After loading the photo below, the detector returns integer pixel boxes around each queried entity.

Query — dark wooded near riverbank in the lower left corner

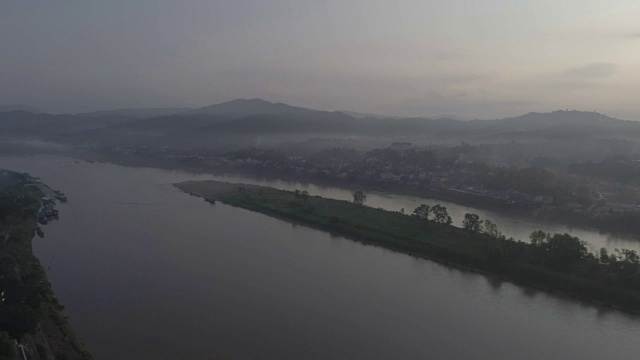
[0,170,91,359]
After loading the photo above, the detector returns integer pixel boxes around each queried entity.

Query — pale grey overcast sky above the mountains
[0,0,640,120]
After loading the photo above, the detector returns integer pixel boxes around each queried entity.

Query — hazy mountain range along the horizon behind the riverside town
[0,99,640,155]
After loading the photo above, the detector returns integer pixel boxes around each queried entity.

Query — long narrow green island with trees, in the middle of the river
[176,181,640,313]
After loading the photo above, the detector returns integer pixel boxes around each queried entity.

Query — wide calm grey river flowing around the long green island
[0,156,640,360]
